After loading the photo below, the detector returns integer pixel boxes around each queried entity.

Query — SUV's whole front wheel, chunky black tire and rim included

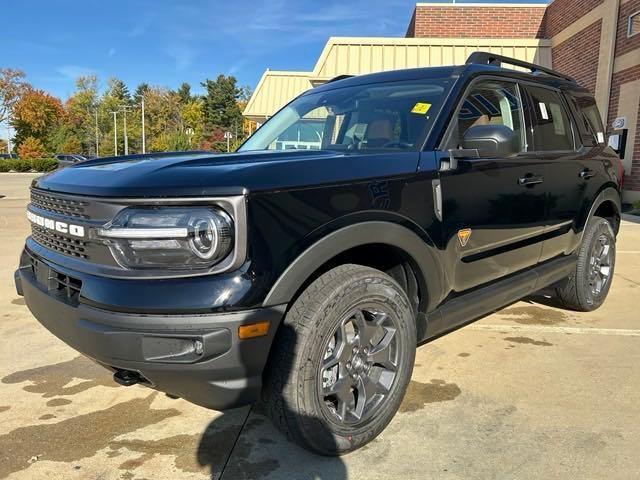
[263,265,416,455]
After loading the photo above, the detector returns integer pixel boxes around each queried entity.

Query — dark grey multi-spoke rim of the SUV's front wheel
[318,305,403,426]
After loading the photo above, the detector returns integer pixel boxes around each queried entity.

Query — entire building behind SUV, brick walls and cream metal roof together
[244,0,640,202]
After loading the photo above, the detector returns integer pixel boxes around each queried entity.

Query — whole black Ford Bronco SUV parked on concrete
[15,53,621,454]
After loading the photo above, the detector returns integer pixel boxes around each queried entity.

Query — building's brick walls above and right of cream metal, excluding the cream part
[407,0,640,201]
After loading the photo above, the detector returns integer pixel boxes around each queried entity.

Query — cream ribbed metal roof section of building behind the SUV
[244,37,551,122]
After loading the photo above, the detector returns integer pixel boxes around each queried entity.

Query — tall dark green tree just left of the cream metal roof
[202,75,242,130]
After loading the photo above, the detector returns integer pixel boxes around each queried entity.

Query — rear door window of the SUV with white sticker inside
[525,86,574,151]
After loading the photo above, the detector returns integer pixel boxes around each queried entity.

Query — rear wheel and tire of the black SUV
[556,217,616,312]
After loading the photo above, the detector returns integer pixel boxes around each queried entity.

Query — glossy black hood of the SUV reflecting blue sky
[34,150,418,197]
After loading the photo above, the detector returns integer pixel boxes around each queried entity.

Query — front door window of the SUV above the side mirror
[447,81,525,151]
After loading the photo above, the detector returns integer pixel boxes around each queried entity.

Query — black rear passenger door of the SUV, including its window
[523,85,602,261]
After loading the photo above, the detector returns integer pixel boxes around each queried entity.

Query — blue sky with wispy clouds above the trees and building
[0,0,544,99]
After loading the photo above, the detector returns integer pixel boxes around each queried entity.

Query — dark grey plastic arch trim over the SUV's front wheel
[263,221,442,311]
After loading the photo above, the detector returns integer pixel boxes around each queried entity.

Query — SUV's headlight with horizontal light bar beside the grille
[98,207,234,270]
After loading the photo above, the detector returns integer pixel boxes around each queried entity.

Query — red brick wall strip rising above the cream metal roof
[406,3,545,38]
